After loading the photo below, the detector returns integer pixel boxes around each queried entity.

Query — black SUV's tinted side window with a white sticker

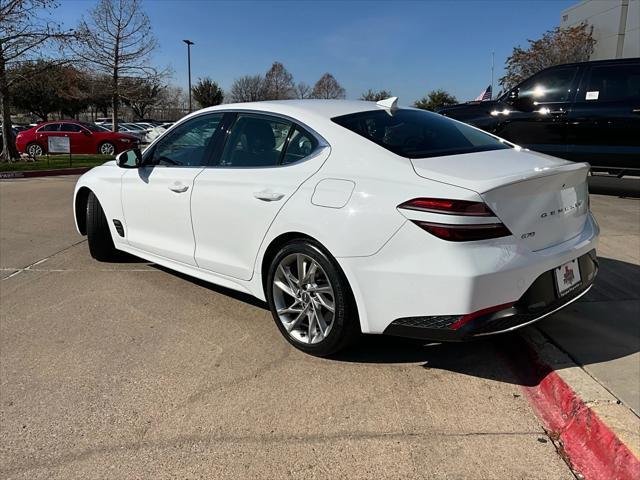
[580,64,640,102]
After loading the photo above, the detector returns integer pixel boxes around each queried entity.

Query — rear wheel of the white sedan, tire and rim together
[266,240,360,357]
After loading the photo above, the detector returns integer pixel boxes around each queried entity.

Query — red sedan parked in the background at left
[16,120,140,157]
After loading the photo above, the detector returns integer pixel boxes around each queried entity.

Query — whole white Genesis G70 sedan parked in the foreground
[74,99,599,355]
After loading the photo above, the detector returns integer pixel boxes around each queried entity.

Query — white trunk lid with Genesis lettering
[412,150,589,251]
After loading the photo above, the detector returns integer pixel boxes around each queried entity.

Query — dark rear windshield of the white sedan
[332,110,511,158]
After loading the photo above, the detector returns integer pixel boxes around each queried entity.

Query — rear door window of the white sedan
[220,114,291,167]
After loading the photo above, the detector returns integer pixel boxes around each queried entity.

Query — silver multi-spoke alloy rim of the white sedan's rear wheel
[272,253,335,344]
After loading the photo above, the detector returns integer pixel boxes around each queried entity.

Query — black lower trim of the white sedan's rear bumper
[384,250,598,341]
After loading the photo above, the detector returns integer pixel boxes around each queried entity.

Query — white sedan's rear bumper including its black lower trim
[338,215,599,340]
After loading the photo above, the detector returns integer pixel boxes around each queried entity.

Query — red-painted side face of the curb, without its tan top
[512,339,640,480]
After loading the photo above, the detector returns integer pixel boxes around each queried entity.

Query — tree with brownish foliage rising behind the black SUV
[499,23,596,90]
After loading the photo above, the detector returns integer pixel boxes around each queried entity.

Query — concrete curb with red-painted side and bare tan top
[513,328,640,480]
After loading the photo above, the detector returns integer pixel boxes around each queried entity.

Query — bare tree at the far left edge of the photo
[0,0,73,161]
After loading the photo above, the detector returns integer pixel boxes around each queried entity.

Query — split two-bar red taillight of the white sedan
[398,198,511,242]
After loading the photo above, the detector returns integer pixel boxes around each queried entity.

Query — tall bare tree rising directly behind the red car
[75,0,158,132]
